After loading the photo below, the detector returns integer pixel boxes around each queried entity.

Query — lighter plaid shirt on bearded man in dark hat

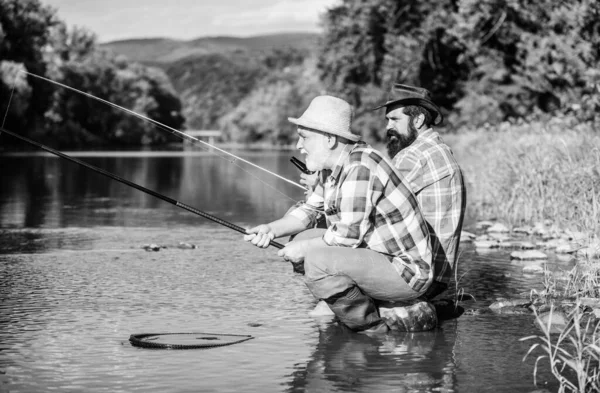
[393,129,467,284]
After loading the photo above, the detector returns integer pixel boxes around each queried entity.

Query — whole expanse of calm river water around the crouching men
[0,151,569,392]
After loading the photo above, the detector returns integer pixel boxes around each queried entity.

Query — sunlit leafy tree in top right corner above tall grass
[452,0,600,123]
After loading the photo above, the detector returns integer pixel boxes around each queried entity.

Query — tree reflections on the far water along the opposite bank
[0,152,303,228]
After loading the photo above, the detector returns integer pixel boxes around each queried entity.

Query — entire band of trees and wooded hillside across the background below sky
[0,0,600,146]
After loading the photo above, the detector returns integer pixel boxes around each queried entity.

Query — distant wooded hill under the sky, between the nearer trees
[101,33,318,129]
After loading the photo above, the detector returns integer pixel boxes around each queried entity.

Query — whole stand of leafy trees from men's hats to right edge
[318,0,600,138]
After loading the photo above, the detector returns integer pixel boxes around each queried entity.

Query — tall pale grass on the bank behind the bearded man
[446,118,600,234]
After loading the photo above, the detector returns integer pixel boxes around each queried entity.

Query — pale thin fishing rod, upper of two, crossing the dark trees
[19,70,307,191]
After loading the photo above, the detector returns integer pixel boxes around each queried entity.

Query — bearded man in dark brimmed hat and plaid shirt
[375,84,466,299]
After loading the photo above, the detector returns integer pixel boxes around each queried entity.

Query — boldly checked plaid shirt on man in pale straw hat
[289,143,433,292]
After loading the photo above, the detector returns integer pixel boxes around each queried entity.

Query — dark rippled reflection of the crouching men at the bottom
[288,321,457,392]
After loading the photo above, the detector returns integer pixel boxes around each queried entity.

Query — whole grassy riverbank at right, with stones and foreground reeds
[445,117,600,391]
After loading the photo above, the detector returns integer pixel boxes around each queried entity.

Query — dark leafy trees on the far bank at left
[0,0,184,147]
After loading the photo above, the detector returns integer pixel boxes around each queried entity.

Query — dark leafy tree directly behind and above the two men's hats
[319,0,468,139]
